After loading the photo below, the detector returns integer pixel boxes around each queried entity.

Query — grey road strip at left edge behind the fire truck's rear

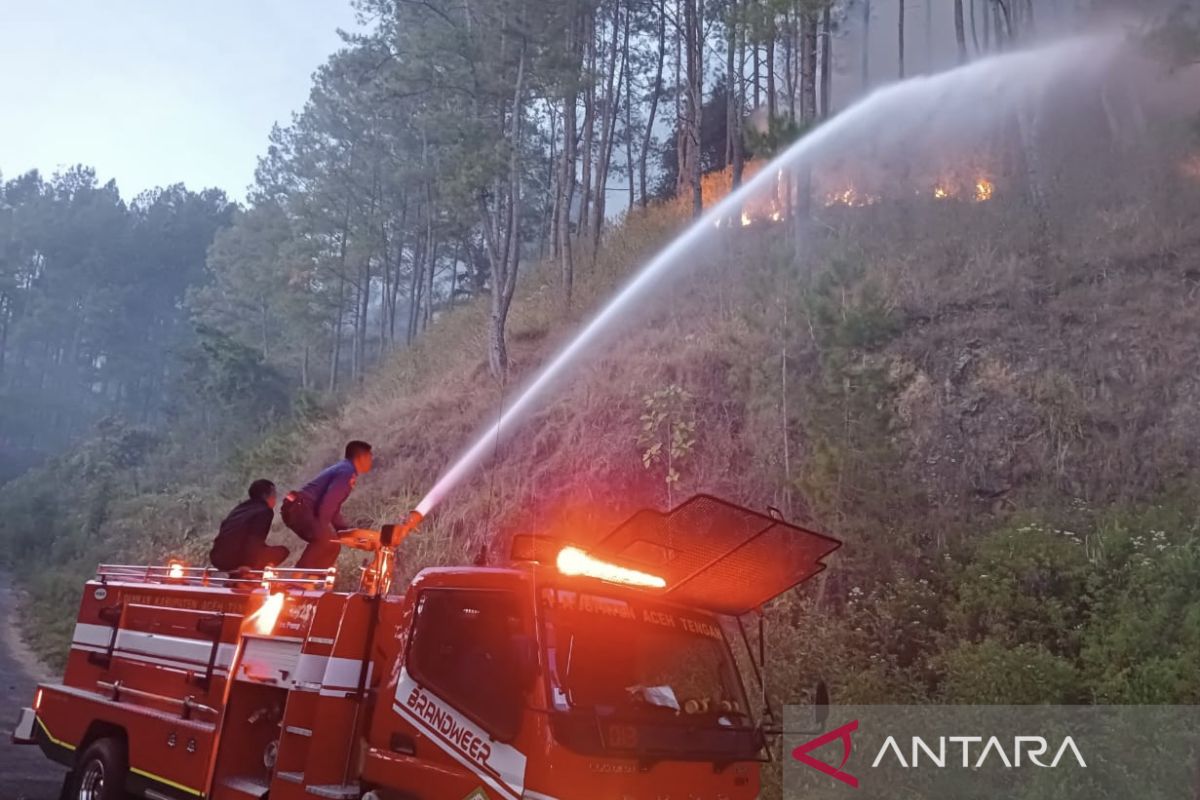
[0,576,62,800]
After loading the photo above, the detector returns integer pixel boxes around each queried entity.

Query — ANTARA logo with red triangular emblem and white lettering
[792,720,1087,788]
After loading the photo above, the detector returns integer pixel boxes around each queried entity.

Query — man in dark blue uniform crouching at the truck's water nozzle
[282,441,372,570]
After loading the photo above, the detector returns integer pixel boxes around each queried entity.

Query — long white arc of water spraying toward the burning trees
[404,36,1120,533]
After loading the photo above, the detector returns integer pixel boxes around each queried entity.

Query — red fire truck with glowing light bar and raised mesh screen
[14,495,839,800]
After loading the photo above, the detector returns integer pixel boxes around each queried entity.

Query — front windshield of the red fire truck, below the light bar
[541,588,752,728]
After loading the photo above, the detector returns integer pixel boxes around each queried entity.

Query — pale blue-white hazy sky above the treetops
[0,0,354,199]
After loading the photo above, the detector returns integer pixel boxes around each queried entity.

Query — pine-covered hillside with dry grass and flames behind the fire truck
[0,0,1200,772]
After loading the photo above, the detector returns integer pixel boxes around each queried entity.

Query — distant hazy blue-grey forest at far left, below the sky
[0,175,233,481]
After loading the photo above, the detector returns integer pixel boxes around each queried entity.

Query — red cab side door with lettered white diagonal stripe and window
[392,588,528,800]
